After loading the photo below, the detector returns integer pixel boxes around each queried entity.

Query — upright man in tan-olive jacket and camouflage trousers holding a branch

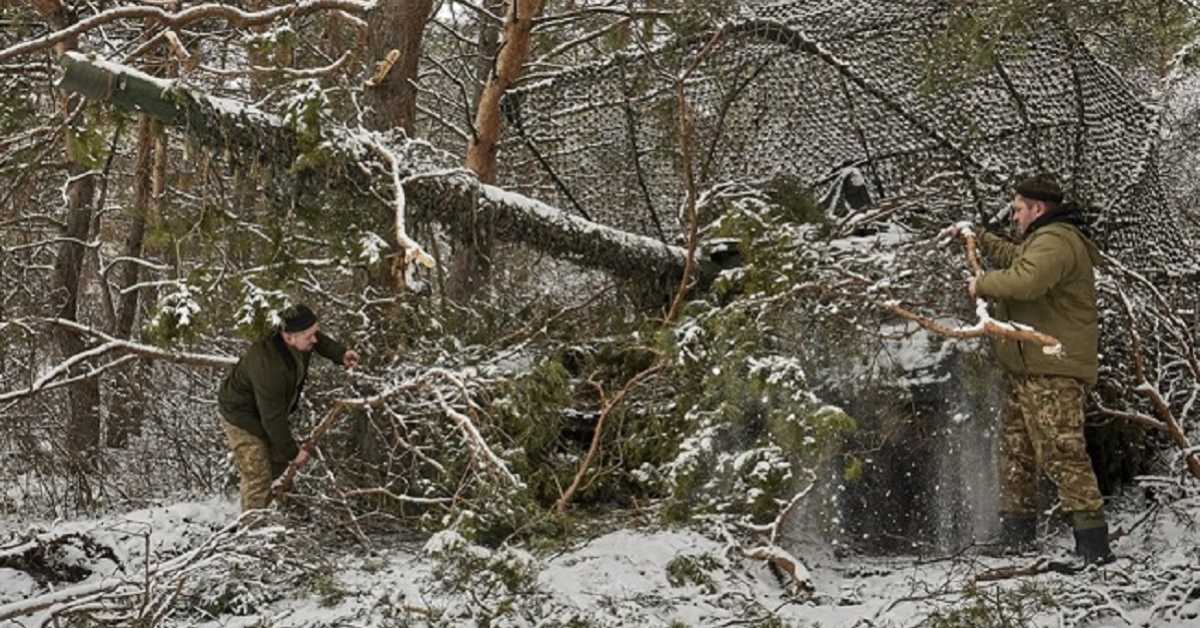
[955,175,1114,563]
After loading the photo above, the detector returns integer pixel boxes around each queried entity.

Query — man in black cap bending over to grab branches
[217,305,359,513]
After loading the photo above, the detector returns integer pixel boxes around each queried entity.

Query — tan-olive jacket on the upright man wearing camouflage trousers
[976,216,1100,384]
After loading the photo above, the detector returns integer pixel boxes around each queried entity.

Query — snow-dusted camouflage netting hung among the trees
[504,0,1198,274]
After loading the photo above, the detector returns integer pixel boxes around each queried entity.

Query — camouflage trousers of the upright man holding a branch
[1000,376,1104,513]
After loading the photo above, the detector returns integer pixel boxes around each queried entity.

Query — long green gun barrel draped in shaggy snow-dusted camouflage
[60,53,685,286]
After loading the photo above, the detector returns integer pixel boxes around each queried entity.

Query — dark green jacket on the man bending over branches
[217,331,346,463]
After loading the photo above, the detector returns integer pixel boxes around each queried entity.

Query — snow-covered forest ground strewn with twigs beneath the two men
[0,497,1200,628]
